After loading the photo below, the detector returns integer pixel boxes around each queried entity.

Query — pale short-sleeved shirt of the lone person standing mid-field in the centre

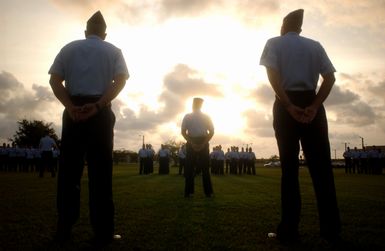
[182,111,214,137]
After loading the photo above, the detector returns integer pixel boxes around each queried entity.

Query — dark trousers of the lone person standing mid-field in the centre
[184,139,213,196]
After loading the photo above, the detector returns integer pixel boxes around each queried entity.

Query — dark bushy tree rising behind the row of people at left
[10,119,59,147]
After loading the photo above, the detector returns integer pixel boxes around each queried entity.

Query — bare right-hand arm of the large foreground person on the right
[305,72,336,123]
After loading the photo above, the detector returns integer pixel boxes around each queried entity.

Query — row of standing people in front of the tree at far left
[0,136,60,177]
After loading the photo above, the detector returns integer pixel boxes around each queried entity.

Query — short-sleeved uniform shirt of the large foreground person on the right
[260,32,336,91]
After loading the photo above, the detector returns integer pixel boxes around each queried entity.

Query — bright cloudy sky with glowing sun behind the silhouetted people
[0,0,385,158]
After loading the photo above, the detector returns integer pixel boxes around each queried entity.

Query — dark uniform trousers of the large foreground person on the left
[57,98,115,240]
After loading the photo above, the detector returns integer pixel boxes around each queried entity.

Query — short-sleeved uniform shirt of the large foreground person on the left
[49,35,129,96]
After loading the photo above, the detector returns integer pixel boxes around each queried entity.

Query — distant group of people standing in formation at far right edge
[344,146,385,174]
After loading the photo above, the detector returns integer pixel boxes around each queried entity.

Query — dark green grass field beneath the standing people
[0,165,385,251]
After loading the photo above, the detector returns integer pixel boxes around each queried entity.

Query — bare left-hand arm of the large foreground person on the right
[266,67,304,122]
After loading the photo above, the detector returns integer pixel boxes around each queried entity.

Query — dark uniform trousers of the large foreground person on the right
[273,91,341,239]
